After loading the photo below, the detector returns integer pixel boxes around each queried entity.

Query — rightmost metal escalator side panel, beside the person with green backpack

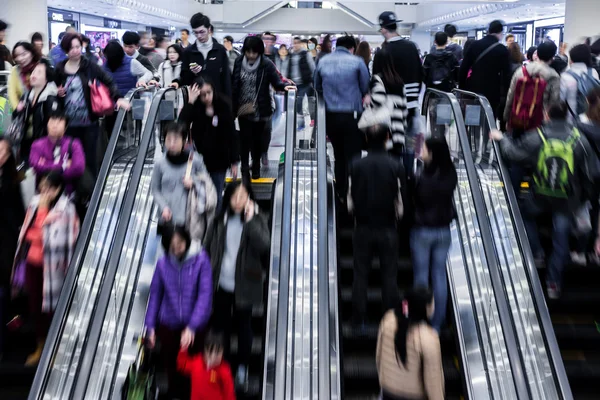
[456,90,573,399]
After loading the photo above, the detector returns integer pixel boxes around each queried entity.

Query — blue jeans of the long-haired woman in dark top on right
[410,227,452,332]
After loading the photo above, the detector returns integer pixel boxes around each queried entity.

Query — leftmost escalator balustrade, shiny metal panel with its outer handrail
[24,89,157,399]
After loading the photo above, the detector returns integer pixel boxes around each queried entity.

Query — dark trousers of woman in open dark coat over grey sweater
[213,287,253,366]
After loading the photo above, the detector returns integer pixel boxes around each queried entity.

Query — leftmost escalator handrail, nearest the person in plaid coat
[28,88,153,400]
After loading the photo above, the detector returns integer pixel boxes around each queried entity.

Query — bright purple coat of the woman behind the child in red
[146,251,213,331]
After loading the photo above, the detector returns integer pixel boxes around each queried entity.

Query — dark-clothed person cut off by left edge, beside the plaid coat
[0,137,25,357]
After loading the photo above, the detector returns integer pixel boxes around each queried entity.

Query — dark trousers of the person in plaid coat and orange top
[25,263,52,340]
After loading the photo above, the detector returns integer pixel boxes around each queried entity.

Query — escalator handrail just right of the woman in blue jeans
[423,89,531,400]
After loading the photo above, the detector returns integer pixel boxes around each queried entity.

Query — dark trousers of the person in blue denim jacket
[326,112,363,200]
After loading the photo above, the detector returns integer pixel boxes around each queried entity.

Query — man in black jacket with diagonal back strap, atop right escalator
[459,21,512,116]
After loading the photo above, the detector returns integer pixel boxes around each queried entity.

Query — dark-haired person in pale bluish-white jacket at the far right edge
[560,44,599,120]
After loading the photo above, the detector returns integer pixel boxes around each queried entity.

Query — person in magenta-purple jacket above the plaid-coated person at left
[29,111,85,196]
